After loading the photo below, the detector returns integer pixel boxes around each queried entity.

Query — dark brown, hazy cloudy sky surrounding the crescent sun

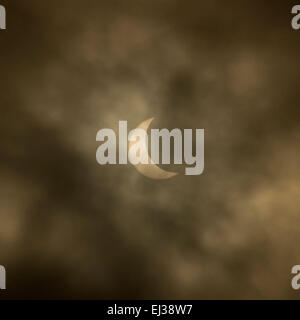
[0,0,300,299]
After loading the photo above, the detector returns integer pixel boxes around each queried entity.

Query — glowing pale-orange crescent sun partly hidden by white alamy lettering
[129,118,177,180]
